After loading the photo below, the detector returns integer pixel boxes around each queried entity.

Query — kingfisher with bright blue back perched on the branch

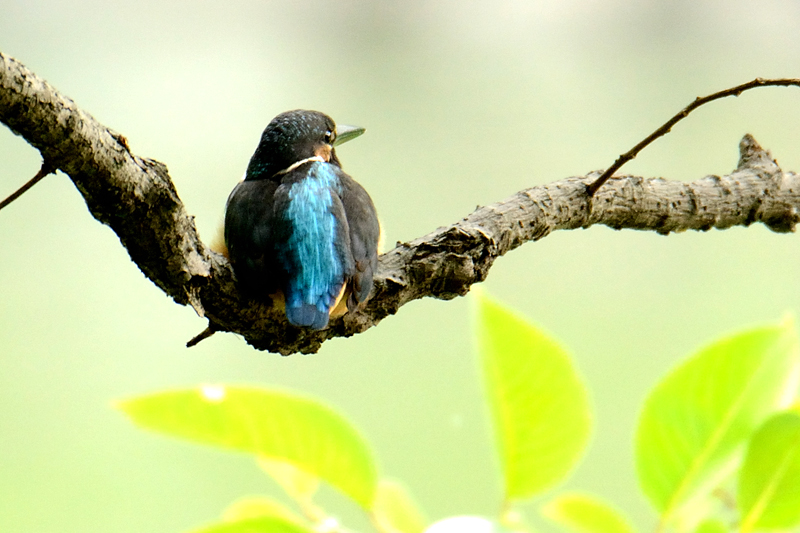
[224,109,380,330]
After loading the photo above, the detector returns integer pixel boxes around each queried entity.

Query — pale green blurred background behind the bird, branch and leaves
[0,0,800,533]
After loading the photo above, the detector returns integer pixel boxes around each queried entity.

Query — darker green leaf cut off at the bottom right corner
[738,411,800,532]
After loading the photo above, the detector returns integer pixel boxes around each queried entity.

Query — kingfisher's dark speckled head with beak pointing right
[245,109,364,180]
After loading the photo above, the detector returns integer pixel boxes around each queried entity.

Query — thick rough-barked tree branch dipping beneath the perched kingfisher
[0,53,800,354]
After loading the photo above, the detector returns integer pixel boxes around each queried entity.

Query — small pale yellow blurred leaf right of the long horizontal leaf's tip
[372,479,428,533]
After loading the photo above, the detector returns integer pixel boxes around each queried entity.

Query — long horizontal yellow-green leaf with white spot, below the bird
[119,386,377,508]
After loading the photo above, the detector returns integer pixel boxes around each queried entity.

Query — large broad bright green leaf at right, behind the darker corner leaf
[636,323,800,522]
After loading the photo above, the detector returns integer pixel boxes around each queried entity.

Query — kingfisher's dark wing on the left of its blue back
[225,180,290,301]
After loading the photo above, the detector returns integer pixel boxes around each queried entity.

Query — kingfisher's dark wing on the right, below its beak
[340,168,381,310]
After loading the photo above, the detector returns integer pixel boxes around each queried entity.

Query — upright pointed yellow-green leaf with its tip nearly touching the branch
[478,295,591,500]
